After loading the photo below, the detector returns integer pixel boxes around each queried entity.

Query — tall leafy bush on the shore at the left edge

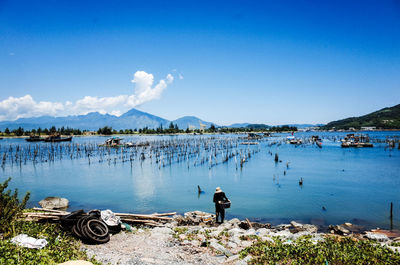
[0,178,30,237]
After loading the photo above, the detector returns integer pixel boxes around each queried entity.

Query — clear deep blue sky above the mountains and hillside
[0,0,400,125]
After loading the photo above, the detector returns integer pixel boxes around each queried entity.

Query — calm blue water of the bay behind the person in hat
[0,132,400,228]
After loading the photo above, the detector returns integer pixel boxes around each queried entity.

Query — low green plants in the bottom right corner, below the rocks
[240,236,400,265]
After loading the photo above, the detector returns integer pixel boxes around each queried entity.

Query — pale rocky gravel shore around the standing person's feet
[82,211,400,265]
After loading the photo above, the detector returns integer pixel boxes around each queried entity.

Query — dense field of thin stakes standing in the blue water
[0,137,260,169]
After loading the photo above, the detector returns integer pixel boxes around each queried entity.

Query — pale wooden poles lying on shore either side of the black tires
[21,208,176,226]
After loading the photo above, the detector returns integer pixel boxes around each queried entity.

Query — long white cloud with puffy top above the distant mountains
[0,71,174,120]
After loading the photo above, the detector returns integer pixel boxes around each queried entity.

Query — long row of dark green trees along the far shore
[0,122,297,136]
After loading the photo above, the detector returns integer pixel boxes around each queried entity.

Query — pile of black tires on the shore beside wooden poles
[61,210,121,244]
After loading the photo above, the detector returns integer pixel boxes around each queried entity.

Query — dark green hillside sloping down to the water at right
[322,104,400,129]
